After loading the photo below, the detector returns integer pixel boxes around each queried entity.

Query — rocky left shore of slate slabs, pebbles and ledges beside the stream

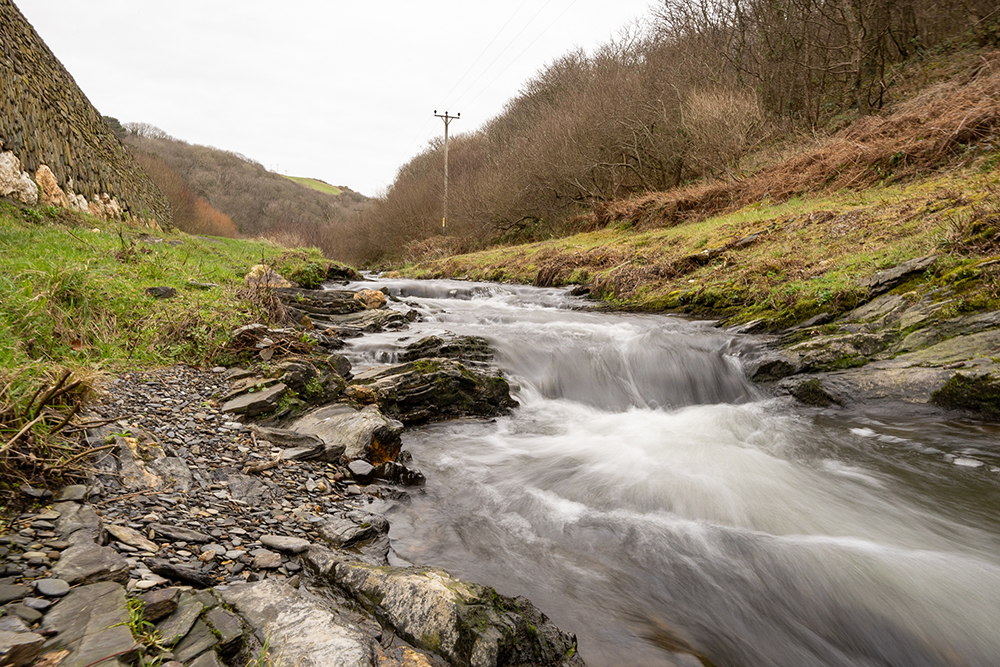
[0,290,583,667]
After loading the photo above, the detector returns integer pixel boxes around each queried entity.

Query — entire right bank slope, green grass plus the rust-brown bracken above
[406,49,1000,328]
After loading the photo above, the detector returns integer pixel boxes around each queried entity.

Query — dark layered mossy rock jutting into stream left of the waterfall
[353,358,517,426]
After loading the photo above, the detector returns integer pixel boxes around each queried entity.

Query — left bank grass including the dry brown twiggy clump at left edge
[0,202,344,503]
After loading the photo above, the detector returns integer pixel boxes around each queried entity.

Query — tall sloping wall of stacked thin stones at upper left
[0,0,170,226]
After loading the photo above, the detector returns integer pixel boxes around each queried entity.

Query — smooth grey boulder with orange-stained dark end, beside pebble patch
[291,404,403,465]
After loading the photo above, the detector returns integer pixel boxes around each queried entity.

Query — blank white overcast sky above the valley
[14,0,655,195]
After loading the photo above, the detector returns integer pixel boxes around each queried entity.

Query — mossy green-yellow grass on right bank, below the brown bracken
[408,164,1000,327]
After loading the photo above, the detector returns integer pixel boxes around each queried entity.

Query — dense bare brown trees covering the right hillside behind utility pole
[336,0,1000,263]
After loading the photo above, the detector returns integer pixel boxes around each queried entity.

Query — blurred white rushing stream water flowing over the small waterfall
[334,280,1000,667]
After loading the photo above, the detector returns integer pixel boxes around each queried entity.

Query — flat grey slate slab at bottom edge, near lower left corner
[43,582,135,667]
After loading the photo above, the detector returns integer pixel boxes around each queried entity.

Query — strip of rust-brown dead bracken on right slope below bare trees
[594,51,1000,227]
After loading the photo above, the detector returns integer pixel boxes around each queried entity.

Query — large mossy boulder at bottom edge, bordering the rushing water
[334,562,583,667]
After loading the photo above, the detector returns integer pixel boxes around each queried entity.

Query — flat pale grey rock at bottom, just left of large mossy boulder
[220,579,374,667]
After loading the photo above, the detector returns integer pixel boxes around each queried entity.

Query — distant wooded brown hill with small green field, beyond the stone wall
[123,129,369,256]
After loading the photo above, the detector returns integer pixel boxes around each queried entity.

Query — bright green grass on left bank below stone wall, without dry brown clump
[0,204,323,374]
